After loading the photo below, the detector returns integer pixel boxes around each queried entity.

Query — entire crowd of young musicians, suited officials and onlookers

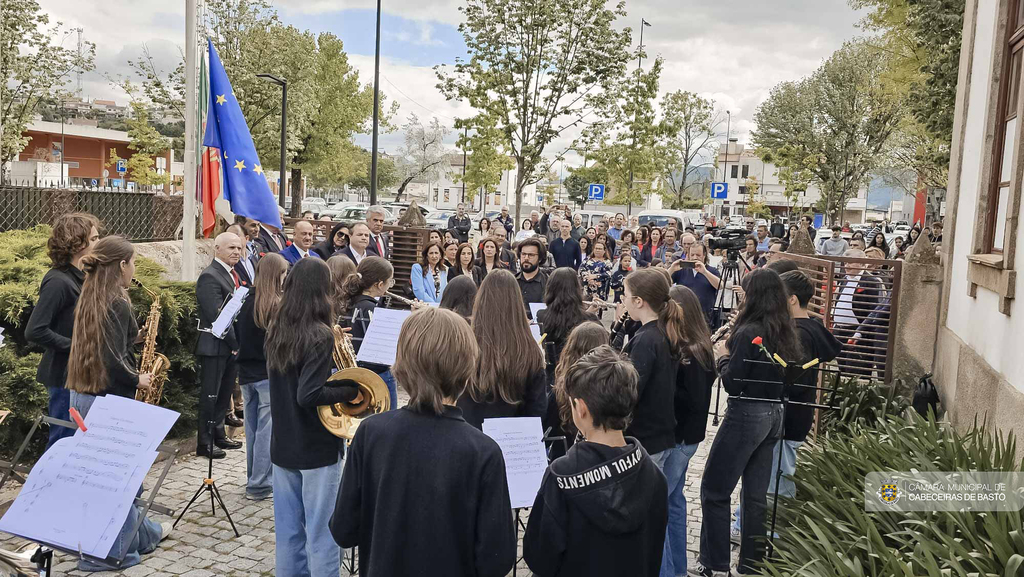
[27,206,941,577]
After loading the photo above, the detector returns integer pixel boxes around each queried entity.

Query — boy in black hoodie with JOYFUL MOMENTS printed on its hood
[523,345,669,577]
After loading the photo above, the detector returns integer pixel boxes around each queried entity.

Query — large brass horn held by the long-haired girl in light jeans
[316,325,391,441]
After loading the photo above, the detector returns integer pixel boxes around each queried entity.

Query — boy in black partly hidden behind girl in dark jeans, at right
[732,271,843,542]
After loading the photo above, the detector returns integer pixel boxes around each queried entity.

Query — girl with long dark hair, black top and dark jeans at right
[698,269,803,573]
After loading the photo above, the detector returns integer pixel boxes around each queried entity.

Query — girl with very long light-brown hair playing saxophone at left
[68,237,171,572]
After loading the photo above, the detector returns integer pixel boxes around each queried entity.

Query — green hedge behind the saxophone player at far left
[0,225,199,457]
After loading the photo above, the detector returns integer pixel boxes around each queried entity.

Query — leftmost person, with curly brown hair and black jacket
[25,212,99,449]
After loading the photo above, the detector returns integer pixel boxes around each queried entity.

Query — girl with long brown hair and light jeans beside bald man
[236,252,288,501]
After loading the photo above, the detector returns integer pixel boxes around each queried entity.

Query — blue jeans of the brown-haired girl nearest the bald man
[242,379,273,498]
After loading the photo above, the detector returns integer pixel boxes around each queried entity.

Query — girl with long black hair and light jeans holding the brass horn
[266,258,361,575]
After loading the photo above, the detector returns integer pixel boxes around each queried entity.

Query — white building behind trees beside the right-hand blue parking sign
[714,138,867,222]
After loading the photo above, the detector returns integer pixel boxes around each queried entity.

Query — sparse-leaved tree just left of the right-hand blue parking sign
[657,90,722,209]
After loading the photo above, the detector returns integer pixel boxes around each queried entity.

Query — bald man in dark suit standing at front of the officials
[196,233,243,459]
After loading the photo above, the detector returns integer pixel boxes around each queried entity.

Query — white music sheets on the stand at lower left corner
[0,395,178,559]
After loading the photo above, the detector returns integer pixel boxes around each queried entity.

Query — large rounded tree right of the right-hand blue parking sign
[751,42,904,221]
